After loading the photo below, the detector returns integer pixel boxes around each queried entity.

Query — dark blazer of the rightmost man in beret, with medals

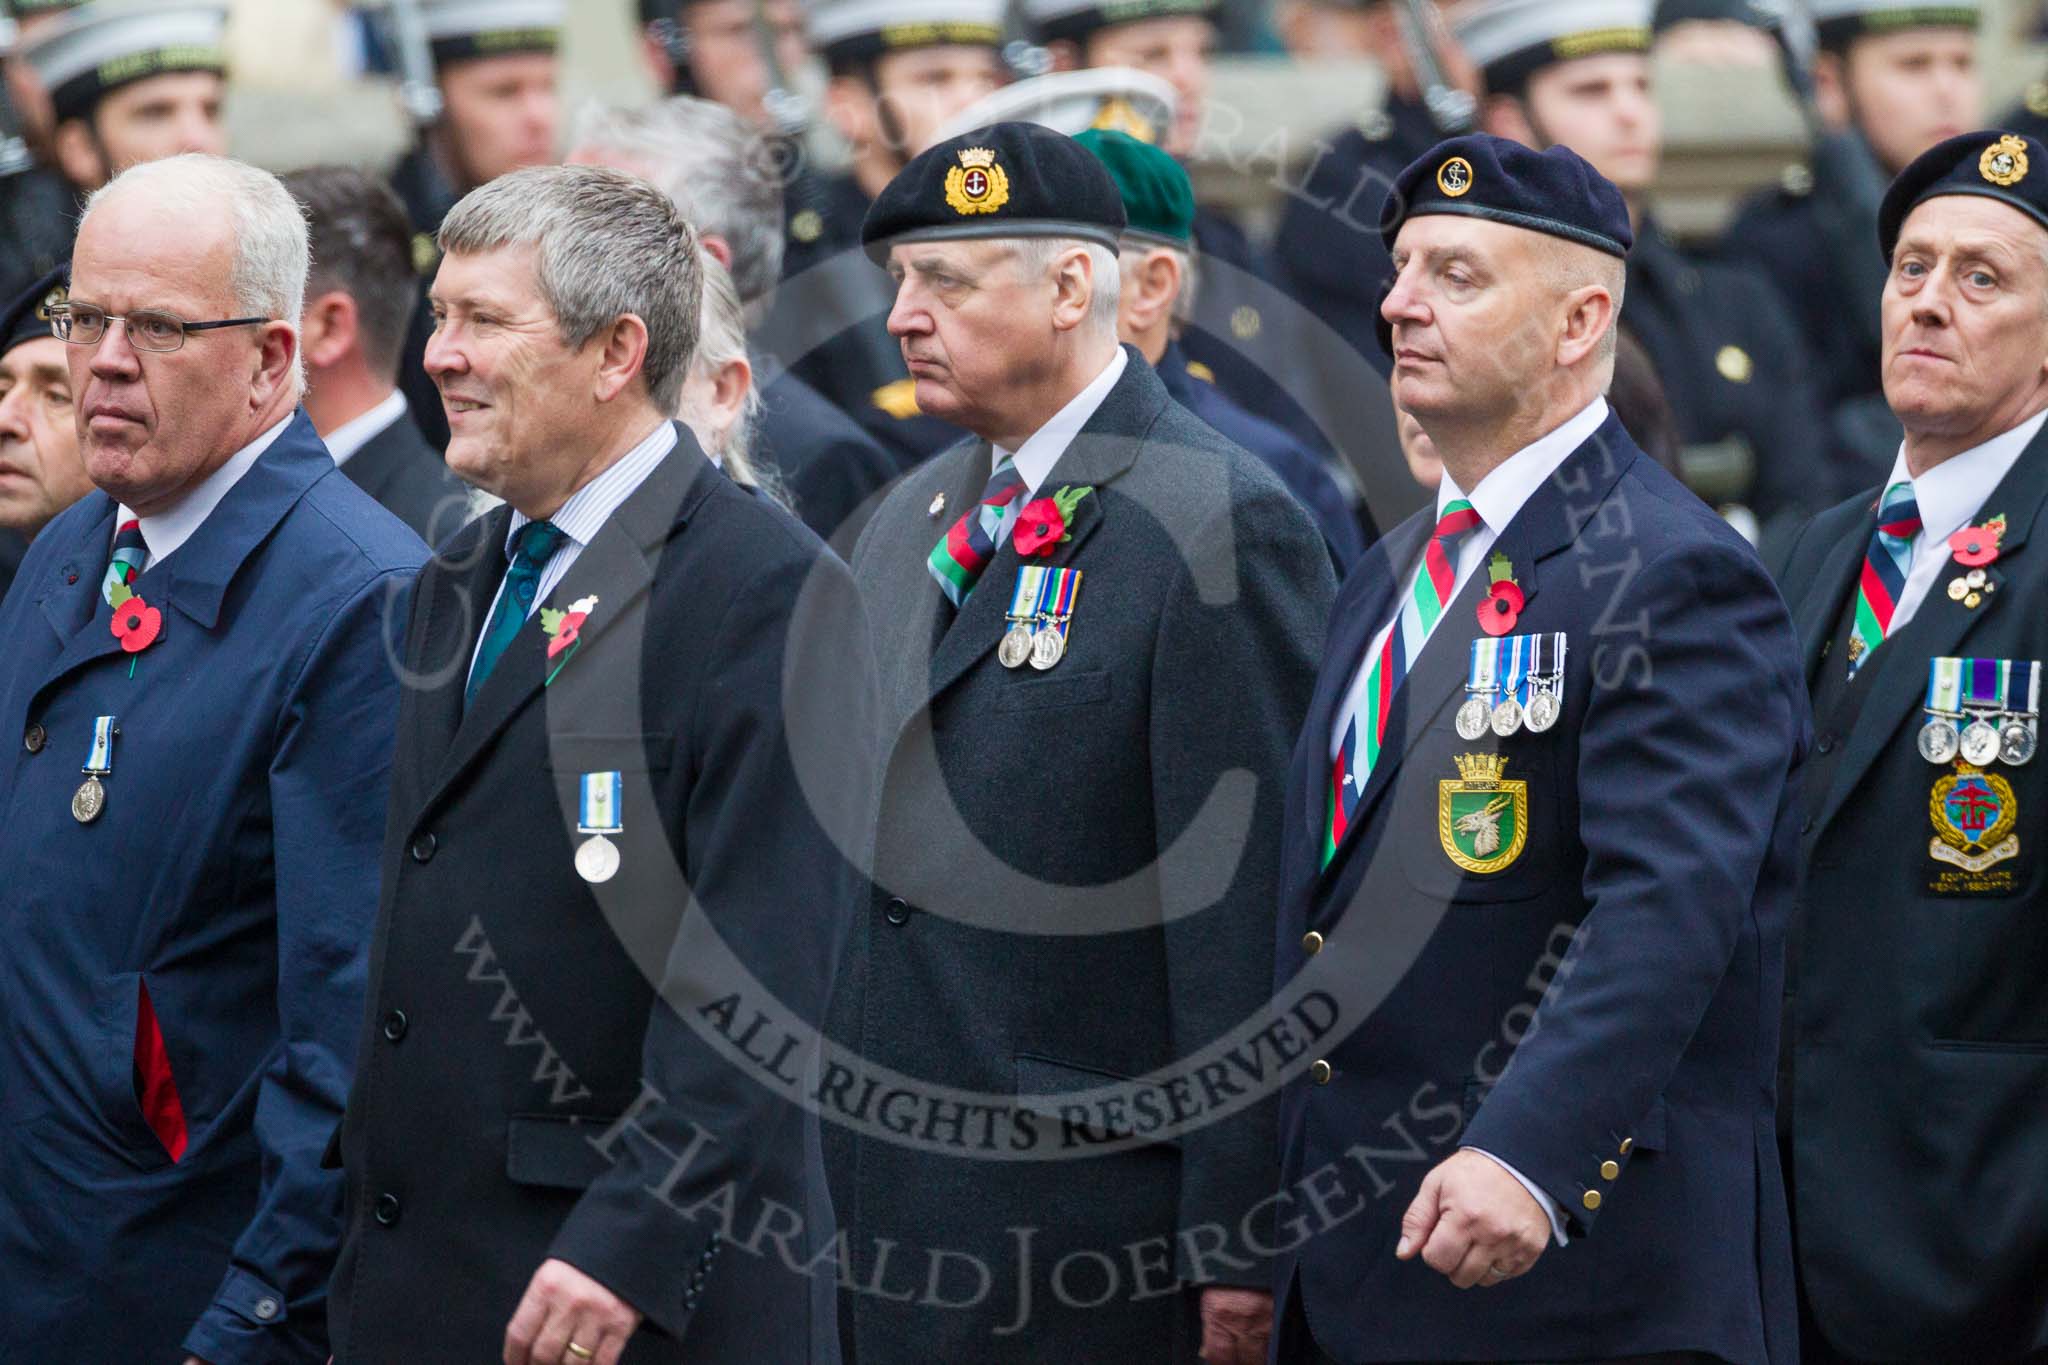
[1782,434,2048,1361]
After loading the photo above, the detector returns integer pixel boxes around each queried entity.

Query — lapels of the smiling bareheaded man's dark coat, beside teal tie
[411,432,723,822]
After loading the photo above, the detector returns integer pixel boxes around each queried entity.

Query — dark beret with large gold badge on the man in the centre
[860,123,1126,264]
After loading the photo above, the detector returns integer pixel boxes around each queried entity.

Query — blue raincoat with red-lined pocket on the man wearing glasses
[0,411,426,1365]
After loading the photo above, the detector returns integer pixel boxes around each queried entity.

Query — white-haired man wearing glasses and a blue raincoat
[0,156,426,1365]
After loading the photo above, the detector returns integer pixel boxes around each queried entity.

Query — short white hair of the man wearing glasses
[84,151,311,393]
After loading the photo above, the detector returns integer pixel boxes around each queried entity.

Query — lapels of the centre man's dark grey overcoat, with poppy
[928,348,1171,700]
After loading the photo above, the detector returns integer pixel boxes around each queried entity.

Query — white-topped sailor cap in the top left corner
[20,0,227,119]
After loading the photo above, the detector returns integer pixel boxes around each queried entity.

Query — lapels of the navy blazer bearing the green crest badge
[1325,413,1638,888]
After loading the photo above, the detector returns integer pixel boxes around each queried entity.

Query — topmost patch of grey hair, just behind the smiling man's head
[569,94,782,311]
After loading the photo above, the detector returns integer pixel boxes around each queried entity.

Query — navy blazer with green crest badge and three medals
[1276,417,1808,1363]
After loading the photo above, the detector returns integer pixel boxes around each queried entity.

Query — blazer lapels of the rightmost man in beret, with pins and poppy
[1815,430,2048,829]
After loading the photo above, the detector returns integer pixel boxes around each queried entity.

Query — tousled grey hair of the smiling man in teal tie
[438,166,702,413]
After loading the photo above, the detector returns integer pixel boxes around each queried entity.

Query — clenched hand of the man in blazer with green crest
[1395,1152,1550,1289]
